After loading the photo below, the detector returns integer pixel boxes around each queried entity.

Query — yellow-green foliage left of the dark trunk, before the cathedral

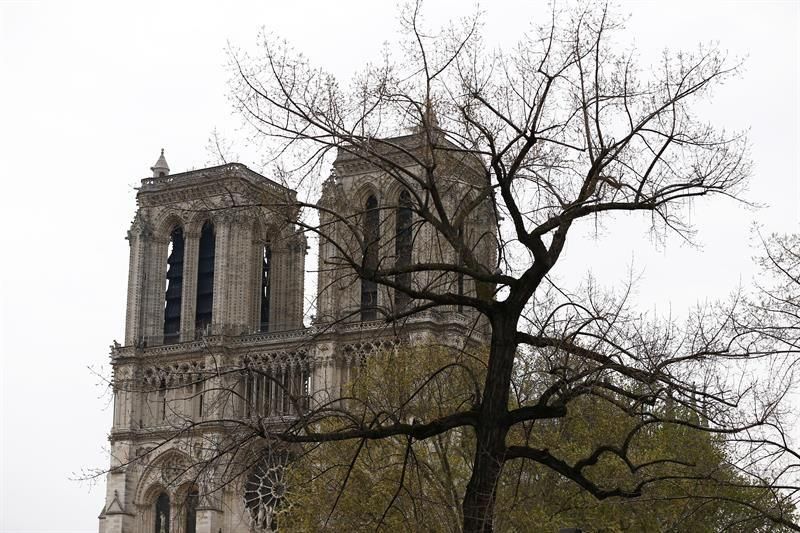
[279,346,483,531]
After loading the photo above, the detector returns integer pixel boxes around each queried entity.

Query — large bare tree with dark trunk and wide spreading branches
[95,4,800,532]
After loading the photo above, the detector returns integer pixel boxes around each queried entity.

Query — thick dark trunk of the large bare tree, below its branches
[462,324,516,533]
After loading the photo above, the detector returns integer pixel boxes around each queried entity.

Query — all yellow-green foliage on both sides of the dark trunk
[279,347,793,532]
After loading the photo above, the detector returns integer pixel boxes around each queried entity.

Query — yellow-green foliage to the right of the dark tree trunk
[497,396,793,532]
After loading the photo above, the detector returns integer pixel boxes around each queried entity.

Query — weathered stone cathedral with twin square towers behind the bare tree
[99,134,496,533]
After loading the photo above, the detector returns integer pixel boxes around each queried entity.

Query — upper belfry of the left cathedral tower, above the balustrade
[125,150,305,346]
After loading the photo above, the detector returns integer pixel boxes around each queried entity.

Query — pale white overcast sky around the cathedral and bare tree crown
[0,0,800,532]
